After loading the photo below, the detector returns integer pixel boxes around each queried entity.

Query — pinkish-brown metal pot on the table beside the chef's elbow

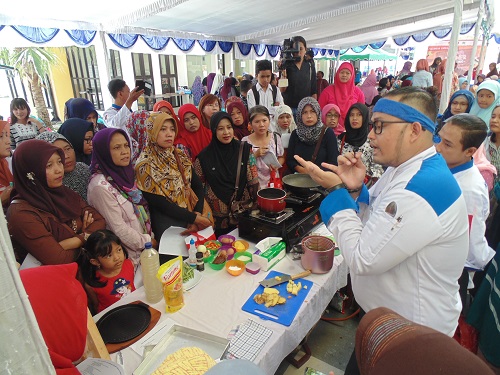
[300,236,335,273]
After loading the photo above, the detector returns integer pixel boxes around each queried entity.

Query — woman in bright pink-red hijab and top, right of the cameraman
[318,62,366,136]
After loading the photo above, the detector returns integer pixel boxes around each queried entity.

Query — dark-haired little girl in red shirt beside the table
[78,229,135,312]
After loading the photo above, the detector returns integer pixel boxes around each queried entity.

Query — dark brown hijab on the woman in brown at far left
[12,139,81,222]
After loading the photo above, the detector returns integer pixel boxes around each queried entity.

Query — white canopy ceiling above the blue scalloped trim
[0,0,492,49]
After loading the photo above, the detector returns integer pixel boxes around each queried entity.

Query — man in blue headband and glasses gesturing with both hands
[296,87,468,352]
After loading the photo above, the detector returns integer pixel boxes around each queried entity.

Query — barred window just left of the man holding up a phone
[66,46,104,110]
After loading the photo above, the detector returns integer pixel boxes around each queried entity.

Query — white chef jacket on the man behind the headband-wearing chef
[451,160,495,270]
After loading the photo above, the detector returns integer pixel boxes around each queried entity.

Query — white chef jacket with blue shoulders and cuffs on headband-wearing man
[320,147,468,336]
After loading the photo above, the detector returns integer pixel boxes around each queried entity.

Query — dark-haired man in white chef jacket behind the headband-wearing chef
[436,113,495,302]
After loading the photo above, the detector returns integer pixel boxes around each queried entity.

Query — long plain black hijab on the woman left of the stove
[198,112,251,204]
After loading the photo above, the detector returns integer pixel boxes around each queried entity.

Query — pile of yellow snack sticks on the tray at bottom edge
[153,347,215,375]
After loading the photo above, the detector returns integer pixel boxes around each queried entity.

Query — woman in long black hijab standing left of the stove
[194,112,259,236]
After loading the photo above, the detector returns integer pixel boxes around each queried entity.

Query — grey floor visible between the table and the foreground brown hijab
[275,311,359,375]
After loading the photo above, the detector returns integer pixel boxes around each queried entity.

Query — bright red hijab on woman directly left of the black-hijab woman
[175,103,212,161]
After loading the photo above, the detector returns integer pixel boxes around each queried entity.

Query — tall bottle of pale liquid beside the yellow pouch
[141,242,163,303]
